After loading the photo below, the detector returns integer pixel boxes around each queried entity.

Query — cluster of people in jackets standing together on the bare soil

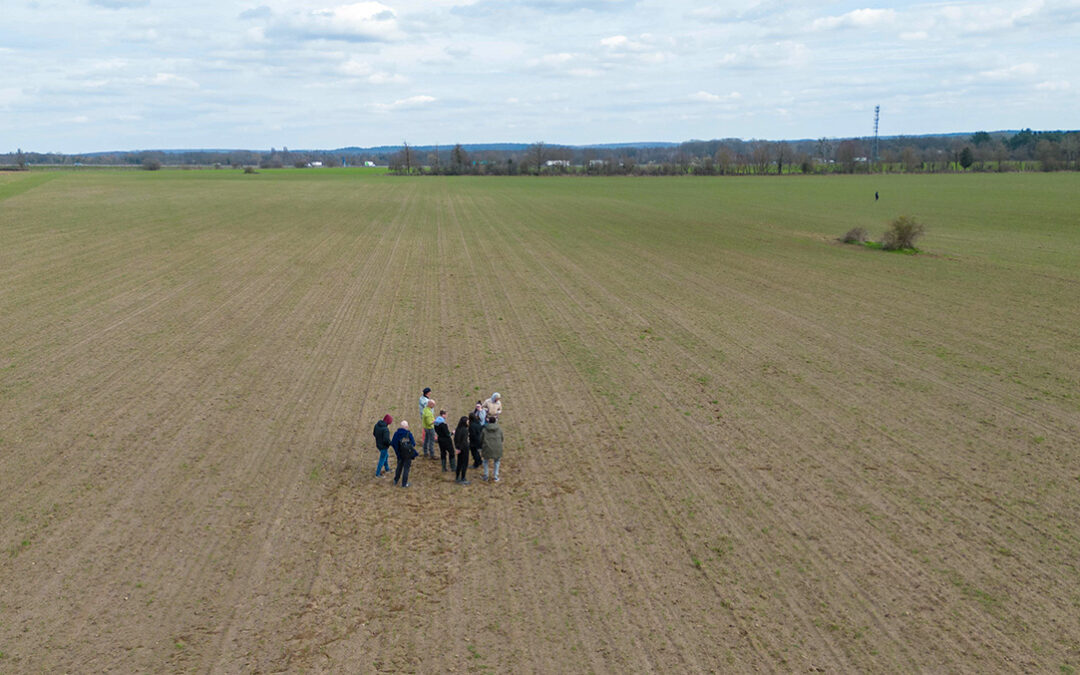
[372,387,502,487]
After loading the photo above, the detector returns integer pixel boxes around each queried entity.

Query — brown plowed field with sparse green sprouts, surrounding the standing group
[0,171,1080,673]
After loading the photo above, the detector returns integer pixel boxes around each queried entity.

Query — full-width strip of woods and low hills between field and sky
[0,129,1080,176]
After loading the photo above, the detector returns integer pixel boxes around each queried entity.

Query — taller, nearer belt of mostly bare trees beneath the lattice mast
[389,129,1080,176]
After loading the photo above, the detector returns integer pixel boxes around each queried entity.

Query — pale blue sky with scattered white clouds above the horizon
[0,0,1080,152]
